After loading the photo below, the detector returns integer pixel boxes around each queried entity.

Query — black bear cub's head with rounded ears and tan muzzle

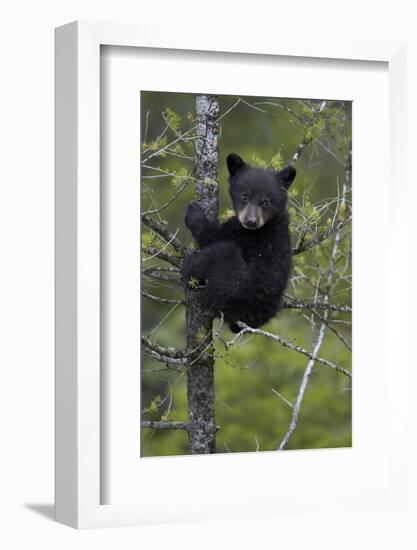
[227,153,296,230]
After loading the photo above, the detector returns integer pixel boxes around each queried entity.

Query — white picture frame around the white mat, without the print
[56,22,406,528]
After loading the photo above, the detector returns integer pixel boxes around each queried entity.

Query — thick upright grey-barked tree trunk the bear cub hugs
[186,95,219,454]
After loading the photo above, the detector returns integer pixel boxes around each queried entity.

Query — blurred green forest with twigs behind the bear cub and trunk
[141,91,352,456]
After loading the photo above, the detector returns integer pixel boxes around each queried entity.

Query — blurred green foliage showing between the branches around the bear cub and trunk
[141,92,352,456]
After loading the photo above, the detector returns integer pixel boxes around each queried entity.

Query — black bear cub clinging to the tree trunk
[182,153,296,332]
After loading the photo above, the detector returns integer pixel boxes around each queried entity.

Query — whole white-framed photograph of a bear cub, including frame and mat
[56,22,407,528]
